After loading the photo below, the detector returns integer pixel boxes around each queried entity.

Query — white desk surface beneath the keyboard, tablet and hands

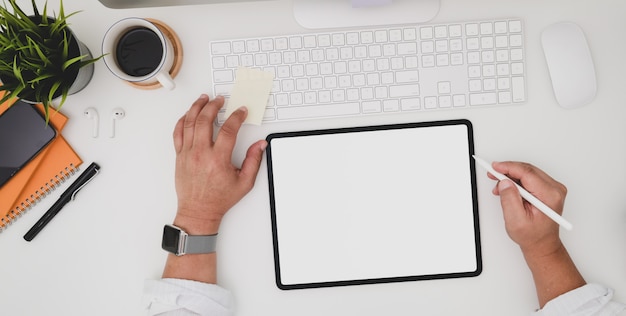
[0,0,626,316]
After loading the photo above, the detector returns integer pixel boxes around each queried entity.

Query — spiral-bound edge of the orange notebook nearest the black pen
[0,164,80,233]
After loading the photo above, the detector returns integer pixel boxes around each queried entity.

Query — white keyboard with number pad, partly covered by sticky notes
[210,19,526,123]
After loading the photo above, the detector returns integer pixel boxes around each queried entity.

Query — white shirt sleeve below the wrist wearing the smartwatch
[143,279,233,316]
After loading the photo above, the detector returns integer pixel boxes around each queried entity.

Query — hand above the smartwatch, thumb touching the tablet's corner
[174,95,267,235]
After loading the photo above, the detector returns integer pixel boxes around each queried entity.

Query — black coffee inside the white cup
[115,27,163,77]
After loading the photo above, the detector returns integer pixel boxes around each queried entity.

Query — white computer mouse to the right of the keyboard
[541,22,597,109]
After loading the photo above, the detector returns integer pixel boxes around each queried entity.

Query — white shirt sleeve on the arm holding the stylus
[532,284,626,316]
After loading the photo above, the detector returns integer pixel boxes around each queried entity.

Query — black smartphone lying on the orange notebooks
[0,101,57,188]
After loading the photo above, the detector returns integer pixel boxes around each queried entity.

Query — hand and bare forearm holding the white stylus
[489,162,586,308]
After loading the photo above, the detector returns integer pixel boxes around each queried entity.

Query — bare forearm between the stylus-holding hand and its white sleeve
[522,243,586,308]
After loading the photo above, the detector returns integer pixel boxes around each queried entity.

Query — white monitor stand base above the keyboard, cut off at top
[293,0,440,29]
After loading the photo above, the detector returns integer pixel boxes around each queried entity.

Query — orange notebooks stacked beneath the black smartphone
[0,100,82,231]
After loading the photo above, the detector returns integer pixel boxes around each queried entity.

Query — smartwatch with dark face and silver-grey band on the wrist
[161,225,217,256]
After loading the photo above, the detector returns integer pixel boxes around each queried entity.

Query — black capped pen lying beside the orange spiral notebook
[24,162,100,241]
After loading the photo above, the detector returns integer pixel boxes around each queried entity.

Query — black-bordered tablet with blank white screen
[266,120,482,290]
